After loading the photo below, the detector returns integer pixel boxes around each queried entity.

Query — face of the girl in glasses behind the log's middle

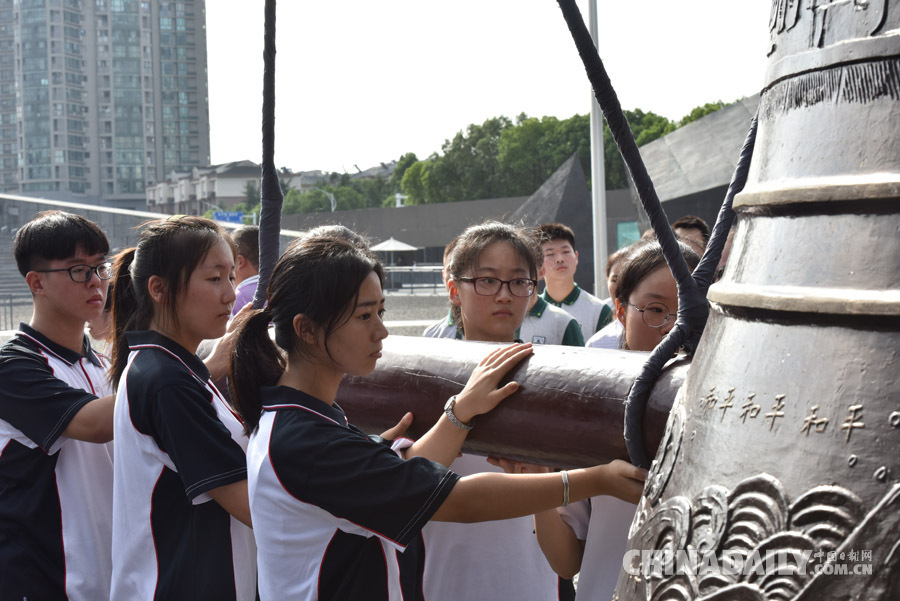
[450,242,532,342]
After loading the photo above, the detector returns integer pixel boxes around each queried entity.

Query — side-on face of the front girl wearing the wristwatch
[317,271,388,376]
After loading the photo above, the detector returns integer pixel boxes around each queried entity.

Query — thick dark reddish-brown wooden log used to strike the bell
[337,336,690,467]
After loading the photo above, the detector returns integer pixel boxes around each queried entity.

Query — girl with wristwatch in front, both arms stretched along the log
[231,232,644,601]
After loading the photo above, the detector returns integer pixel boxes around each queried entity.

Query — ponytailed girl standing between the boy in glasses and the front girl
[112,217,256,601]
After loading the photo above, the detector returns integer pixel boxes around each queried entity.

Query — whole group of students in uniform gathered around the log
[0,211,712,601]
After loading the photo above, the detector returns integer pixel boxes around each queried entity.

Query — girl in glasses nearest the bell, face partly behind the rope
[534,240,700,601]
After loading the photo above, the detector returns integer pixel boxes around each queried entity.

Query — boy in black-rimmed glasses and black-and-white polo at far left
[0,211,115,601]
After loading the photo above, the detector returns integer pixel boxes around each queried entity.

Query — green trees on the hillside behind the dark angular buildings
[282,101,726,214]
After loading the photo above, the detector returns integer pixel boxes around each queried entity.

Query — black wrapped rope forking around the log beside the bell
[558,0,756,468]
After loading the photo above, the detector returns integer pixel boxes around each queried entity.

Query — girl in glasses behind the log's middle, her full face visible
[414,222,571,601]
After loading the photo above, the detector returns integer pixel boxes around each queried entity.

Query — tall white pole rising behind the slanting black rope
[588,0,609,298]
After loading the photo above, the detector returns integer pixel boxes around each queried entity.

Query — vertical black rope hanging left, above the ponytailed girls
[253,0,284,309]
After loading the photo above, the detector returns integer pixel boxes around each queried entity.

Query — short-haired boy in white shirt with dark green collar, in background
[536,223,613,340]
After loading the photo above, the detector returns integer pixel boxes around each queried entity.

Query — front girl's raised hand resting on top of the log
[454,342,534,423]
